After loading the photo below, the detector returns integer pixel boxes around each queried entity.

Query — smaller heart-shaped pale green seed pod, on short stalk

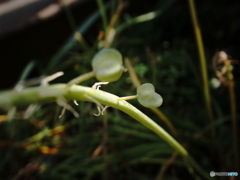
[137,83,163,108]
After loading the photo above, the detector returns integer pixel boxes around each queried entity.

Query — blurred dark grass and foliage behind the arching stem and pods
[0,0,240,180]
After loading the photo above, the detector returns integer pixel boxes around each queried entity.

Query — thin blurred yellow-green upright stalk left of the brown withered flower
[188,0,216,139]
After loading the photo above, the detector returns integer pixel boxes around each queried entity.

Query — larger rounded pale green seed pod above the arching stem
[92,48,123,82]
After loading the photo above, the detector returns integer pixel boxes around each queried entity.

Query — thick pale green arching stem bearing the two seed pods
[0,84,210,179]
